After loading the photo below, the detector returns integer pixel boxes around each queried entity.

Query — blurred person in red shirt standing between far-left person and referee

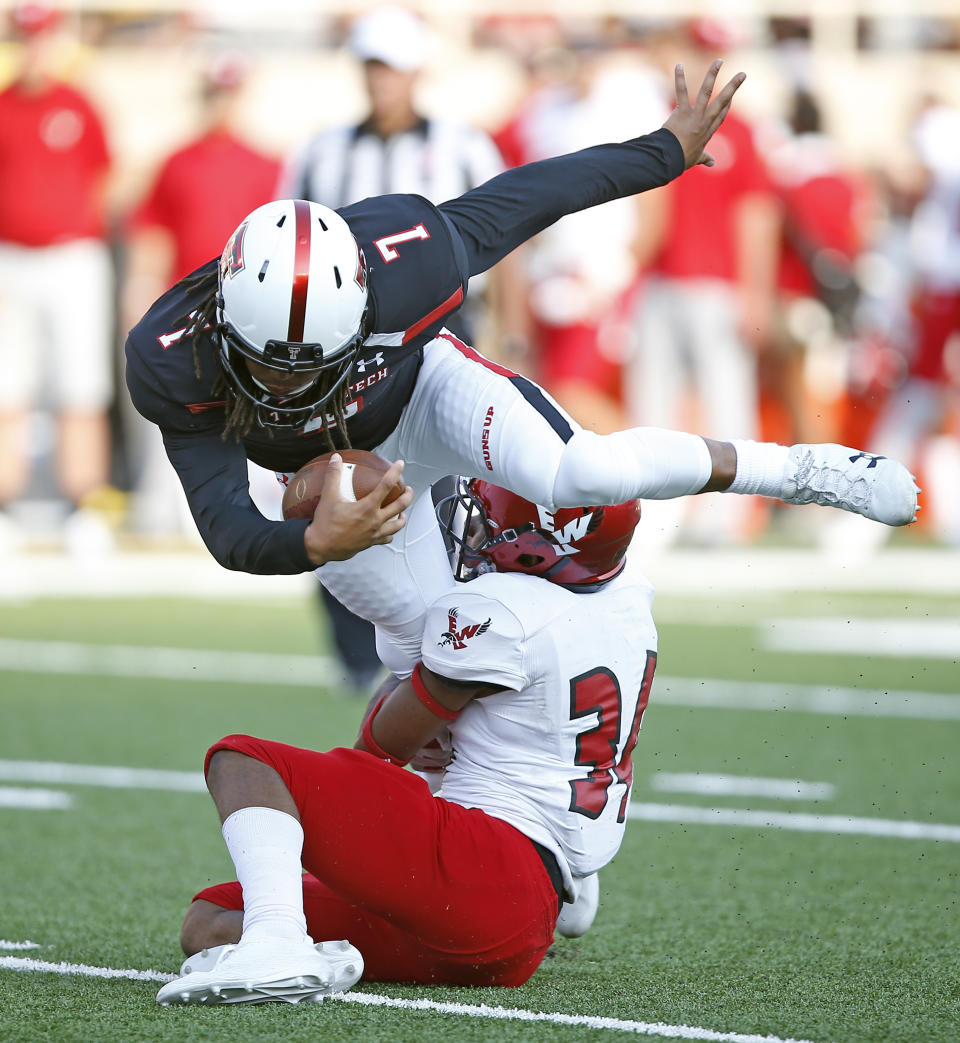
[122,52,281,535]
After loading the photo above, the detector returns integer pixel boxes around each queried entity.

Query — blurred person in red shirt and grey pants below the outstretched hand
[624,19,779,545]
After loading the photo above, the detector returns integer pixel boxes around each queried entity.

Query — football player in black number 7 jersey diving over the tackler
[126,62,916,674]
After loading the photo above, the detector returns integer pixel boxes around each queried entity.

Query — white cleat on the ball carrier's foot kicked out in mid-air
[781,442,920,525]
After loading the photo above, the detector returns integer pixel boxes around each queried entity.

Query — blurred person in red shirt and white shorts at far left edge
[0,3,114,552]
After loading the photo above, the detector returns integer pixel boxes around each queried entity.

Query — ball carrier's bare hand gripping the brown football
[304,454,413,565]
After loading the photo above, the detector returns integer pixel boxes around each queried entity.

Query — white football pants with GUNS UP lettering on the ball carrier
[317,338,578,675]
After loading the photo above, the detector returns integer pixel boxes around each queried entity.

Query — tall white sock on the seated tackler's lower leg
[223,807,307,943]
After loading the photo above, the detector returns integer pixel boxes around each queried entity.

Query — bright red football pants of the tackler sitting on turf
[195,735,558,986]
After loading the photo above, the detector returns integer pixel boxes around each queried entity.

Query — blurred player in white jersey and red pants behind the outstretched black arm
[495,20,668,433]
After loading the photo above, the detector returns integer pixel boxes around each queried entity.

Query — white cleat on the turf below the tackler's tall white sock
[157,938,363,1006]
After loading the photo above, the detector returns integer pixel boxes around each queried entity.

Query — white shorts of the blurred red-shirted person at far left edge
[0,239,114,412]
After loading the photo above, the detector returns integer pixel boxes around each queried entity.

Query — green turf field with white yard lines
[0,575,960,1043]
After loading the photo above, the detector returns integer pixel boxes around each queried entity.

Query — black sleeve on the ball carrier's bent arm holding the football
[163,431,316,576]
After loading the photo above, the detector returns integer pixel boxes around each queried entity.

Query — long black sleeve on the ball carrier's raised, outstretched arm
[439,128,685,275]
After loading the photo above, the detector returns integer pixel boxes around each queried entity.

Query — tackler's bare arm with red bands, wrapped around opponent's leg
[354,663,505,765]
